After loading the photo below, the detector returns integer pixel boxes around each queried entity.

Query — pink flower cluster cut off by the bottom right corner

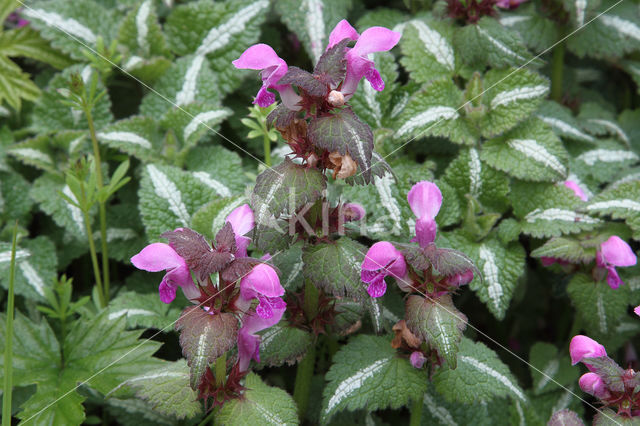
[569,335,640,418]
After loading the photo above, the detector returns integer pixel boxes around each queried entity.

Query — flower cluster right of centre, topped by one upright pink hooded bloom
[360,181,475,368]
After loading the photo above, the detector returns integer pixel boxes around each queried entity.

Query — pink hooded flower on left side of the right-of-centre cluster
[360,241,407,297]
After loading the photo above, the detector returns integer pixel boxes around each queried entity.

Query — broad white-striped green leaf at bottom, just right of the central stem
[321,335,428,423]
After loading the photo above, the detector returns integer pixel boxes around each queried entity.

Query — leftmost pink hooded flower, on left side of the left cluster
[131,243,200,303]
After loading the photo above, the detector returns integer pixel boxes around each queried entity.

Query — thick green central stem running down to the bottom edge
[293,280,319,421]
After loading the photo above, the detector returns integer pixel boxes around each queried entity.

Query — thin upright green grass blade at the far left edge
[2,221,18,426]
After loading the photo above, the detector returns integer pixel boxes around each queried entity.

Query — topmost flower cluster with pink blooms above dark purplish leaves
[233,20,400,180]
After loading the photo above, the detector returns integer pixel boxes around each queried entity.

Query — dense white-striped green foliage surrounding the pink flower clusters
[0,0,640,426]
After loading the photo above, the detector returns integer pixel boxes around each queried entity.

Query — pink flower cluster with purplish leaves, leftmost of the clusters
[131,204,286,382]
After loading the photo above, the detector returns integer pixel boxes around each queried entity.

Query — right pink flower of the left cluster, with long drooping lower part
[237,263,287,371]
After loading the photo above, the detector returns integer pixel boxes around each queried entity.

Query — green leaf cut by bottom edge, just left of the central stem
[215,373,298,425]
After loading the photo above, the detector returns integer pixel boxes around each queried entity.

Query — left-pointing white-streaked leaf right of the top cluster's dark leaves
[395,79,476,145]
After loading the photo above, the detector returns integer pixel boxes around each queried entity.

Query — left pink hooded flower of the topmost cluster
[233,43,301,111]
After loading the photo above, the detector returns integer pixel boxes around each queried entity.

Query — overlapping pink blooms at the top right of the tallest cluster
[327,20,402,100]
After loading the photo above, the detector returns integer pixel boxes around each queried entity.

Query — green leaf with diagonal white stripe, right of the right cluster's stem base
[433,337,527,404]
